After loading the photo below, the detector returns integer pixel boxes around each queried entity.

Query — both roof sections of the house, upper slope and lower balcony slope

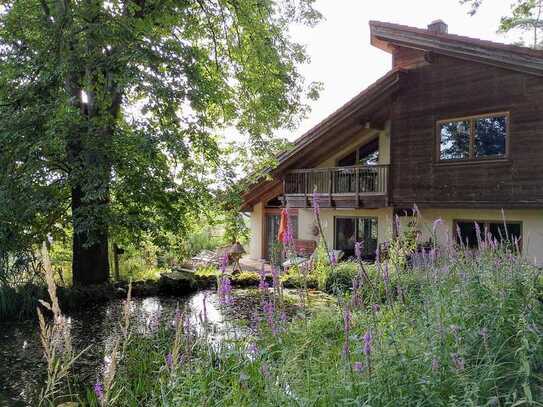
[243,21,543,210]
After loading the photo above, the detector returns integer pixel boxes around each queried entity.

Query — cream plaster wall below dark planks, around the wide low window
[416,209,543,266]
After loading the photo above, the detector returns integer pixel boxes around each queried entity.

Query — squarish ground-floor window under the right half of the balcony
[334,217,377,259]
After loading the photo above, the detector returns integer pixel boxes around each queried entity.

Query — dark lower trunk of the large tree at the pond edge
[72,187,109,286]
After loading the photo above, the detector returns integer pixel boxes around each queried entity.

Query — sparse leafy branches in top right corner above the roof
[460,0,543,49]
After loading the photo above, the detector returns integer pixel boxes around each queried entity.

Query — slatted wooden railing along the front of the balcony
[285,165,388,195]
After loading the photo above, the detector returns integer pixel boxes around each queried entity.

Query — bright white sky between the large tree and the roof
[281,0,519,141]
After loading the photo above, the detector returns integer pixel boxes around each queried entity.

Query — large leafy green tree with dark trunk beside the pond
[0,0,320,285]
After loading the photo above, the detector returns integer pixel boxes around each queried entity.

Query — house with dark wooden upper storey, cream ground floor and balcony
[243,20,543,264]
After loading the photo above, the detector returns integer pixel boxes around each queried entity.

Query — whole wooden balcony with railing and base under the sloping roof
[283,165,389,208]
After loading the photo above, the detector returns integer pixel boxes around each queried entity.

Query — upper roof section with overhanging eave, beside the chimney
[370,21,543,76]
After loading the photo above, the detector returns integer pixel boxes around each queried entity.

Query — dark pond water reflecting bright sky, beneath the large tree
[0,290,256,406]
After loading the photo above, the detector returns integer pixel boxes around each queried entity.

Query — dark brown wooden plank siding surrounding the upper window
[390,56,543,208]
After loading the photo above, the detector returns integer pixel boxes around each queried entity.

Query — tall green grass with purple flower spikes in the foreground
[45,212,543,406]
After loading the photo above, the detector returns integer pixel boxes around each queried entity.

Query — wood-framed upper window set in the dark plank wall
[437,113,509,161]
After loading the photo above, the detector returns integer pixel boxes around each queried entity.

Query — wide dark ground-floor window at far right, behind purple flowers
[455,220,522,249]
